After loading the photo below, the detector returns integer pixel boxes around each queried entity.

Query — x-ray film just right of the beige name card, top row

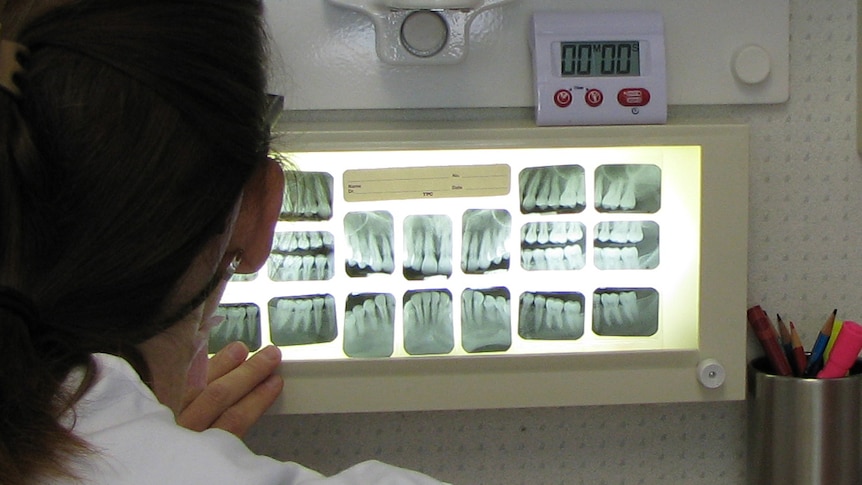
[518,165,586,214]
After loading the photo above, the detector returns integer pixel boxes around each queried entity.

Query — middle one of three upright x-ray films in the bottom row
[404,290,455,355]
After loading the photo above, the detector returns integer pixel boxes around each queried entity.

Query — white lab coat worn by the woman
[54,354,448,485]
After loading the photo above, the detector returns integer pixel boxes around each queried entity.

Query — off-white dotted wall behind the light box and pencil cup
[247,0,862,485]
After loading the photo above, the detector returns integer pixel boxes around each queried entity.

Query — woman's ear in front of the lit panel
[227,160,284,273]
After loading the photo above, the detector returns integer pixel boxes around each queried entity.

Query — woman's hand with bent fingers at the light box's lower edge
[177,342,284,438]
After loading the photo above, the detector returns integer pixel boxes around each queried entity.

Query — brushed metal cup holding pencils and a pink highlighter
[748,357,862,485]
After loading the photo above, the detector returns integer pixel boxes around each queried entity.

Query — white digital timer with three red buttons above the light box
[531,11,667,125]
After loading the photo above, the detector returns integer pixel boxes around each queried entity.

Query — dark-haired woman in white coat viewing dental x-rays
[0,0,446,484]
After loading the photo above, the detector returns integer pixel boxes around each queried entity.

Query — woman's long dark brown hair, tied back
[0,0,269,484]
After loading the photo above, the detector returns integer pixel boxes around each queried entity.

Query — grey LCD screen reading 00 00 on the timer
[560,41,641,77]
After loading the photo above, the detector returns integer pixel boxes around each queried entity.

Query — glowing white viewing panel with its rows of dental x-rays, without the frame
[210,146,700,360]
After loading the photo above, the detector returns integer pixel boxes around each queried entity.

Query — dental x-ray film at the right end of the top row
[596,164,661,213]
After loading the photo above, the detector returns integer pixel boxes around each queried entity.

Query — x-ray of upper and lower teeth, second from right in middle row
[521,221,586,271]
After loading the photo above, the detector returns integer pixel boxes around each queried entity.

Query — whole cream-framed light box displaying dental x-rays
[216,122,748,412]
